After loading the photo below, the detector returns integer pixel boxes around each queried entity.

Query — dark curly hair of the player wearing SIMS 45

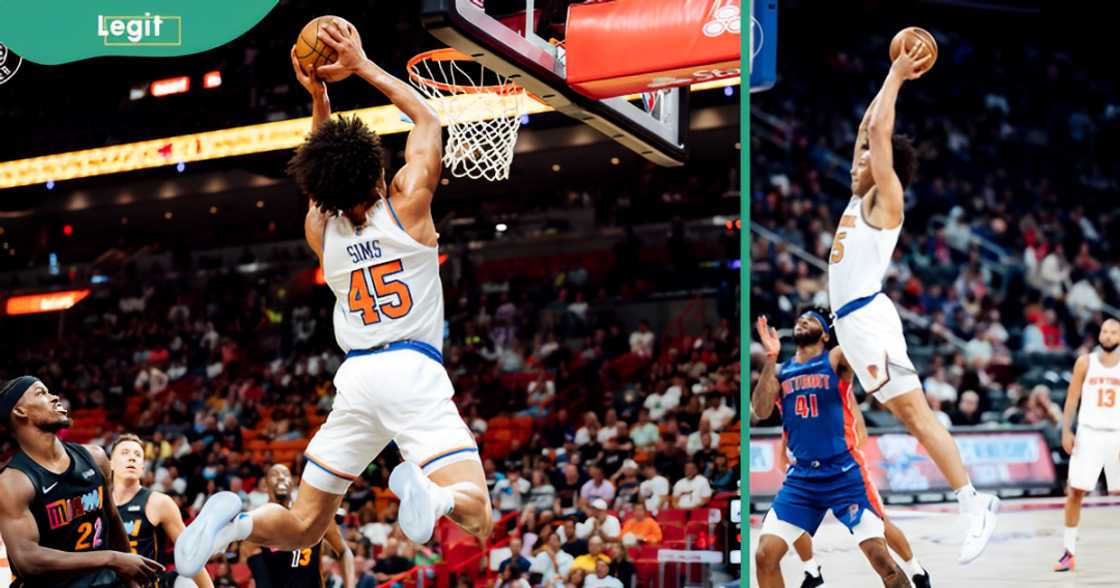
[288,115,385,214]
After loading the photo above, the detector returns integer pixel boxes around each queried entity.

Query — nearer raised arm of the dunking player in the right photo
[867,43,932,227]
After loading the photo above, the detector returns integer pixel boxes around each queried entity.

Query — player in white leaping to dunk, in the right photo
[829,38,999,563]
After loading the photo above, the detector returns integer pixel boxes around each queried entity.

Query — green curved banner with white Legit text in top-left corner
[0,0,277,65]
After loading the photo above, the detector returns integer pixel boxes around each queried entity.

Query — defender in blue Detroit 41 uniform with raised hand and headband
[750,310,911,588]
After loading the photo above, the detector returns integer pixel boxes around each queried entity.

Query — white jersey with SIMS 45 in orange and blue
[323,199,444,352]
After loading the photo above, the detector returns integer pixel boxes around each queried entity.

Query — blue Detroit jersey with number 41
[777,352,857,475]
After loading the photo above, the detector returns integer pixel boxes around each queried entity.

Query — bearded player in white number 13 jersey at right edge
[1054,318,1120,571]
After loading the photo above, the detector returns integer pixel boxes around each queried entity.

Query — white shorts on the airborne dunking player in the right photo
[833,295,922,402]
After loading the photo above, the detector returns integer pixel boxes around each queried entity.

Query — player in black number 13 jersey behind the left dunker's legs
[241,464,356,588]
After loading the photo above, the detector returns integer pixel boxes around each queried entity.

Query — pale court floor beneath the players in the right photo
[750,497,1120,588]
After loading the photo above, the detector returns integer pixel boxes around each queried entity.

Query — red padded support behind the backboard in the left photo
[564,0,740,99]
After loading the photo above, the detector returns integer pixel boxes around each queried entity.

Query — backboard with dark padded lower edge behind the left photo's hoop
[421,0,689,167]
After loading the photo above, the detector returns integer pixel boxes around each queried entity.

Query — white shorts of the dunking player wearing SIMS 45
[304,349,478,494]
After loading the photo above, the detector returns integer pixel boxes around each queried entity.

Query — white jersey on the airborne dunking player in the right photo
[829,196,903,312]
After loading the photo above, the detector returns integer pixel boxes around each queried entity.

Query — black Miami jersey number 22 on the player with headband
[8,442,123,588]
